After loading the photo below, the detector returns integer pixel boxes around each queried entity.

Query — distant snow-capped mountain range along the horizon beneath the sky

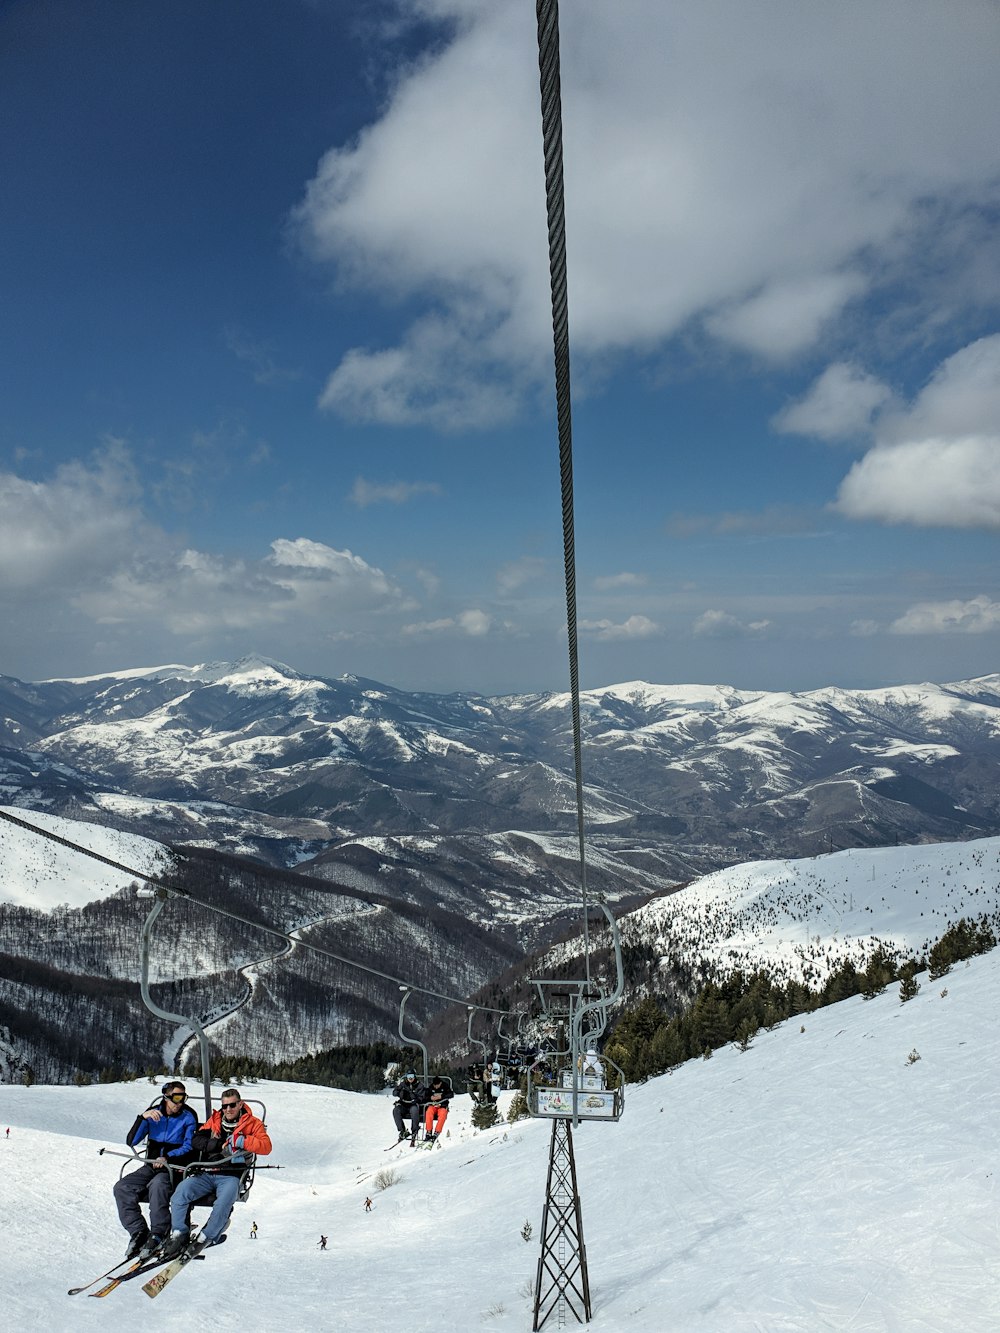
[0,657,1000,893]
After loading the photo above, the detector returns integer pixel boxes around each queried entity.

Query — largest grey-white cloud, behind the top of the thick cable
[292,0,1000,428]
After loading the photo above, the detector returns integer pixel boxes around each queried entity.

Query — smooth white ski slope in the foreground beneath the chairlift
[0,950,1000,1333]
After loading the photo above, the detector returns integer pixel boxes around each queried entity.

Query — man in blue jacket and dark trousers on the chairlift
[115,1080,197,1258]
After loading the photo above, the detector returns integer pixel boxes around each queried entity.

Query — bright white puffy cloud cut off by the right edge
[835,335,1000,529]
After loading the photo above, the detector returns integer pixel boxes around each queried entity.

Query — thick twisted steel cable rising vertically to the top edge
[536,0,591,985]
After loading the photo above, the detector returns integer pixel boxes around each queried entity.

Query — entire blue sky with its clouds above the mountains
[0,0,1000,693]
